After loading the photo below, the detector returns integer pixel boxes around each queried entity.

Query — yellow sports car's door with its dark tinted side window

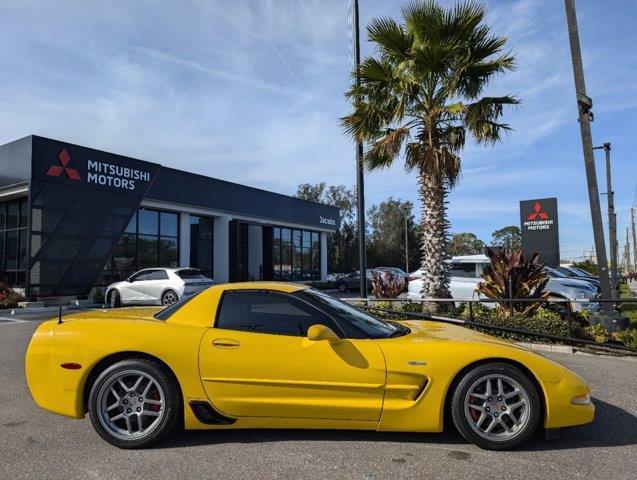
[199,290,385,421]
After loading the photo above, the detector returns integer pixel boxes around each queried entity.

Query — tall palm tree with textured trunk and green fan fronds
[341,0,519,311]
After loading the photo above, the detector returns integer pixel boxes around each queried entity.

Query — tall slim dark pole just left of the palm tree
[354,0,367,298]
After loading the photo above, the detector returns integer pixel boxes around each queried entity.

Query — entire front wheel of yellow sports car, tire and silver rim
[451,363,541,450]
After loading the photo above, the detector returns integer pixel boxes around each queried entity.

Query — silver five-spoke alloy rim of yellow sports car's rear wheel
[97,370,166,440]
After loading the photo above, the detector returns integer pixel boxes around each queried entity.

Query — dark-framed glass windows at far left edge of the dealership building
[0,198,29,287]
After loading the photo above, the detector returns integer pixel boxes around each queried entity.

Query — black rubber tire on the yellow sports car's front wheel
[451,362,542,450]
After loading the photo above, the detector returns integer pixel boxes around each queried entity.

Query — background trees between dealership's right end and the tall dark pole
[295,182,358,272]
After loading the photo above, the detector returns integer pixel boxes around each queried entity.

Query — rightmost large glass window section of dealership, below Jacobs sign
[272,227,321,281]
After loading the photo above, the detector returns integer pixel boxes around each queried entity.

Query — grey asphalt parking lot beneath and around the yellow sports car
[0,315,637,480]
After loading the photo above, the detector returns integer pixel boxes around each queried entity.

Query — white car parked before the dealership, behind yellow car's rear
[105,268,214,308]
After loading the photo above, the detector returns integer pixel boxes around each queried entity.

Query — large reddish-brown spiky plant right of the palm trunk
[476,248,549,316]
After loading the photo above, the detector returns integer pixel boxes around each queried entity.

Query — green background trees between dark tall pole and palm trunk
[367,197,420,272]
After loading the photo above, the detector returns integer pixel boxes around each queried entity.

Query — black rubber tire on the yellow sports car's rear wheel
[88,358,181,449]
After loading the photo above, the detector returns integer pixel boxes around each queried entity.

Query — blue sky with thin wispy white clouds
[0,0,637,258]
